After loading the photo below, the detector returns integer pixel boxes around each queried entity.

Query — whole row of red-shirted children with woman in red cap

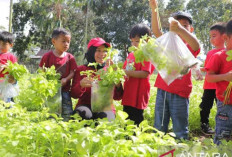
[0,0,232,144]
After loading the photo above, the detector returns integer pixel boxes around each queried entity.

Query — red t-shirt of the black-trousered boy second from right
[203,48,224,89]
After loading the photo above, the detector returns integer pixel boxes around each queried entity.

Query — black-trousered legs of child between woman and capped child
[123,106,144,125]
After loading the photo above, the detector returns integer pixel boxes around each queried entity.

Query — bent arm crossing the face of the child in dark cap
[170,20,200,51]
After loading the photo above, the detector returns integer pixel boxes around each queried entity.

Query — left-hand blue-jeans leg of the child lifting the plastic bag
[154,89,170,133]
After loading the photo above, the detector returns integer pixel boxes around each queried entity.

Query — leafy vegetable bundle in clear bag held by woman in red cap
[81,49,125,112]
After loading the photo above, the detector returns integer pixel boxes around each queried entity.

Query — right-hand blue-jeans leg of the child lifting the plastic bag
[169,93,189,139]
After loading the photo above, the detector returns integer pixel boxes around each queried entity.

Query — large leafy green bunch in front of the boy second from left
[15,66,61,111]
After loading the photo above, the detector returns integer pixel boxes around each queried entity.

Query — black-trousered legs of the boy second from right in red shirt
[200,89,216,124]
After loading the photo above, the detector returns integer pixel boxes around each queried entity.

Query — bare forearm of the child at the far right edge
[205,71,232,82]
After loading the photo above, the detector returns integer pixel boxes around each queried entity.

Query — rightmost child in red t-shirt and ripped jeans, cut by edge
[205,19,232,144]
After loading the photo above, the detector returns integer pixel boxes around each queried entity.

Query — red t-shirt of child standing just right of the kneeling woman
[122,53,155,109]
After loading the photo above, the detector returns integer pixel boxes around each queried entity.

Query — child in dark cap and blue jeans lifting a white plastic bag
[150,0,200,139]
